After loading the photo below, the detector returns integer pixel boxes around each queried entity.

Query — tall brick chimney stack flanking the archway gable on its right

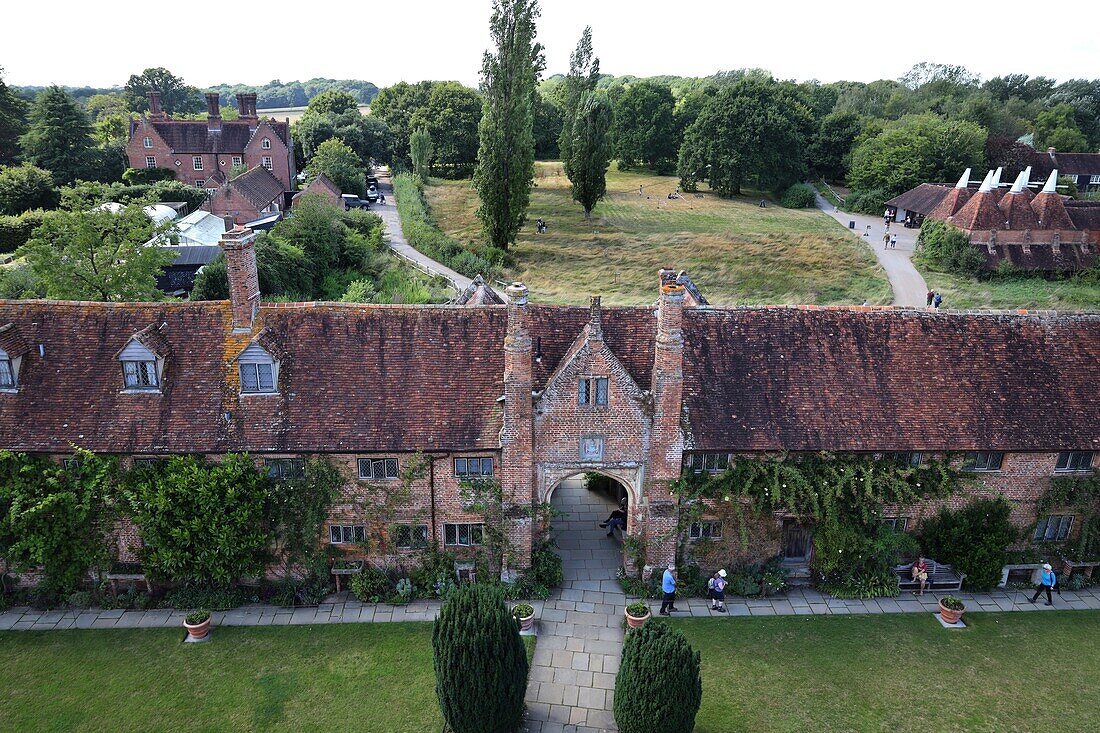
[645,277,684,567]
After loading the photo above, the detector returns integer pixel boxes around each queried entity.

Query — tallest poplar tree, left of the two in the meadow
[474,0,545,250]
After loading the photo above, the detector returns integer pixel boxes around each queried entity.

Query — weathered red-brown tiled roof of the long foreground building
[0,300,1100,455]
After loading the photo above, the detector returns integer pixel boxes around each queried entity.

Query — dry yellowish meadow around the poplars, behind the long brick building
[427,163,891,305]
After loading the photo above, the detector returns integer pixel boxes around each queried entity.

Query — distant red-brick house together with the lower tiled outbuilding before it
[127,91,297,223]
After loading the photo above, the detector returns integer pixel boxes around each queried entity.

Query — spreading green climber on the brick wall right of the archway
[673,452,971,597]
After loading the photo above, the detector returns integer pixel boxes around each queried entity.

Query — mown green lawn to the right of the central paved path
[675,611,1100,733]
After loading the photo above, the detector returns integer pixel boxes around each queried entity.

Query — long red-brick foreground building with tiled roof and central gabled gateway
[0,228,1100,567]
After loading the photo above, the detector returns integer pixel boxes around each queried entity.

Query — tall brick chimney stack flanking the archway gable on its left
[501,283,535,568]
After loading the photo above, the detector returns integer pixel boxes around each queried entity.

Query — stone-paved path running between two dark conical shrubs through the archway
[527,479,626,733]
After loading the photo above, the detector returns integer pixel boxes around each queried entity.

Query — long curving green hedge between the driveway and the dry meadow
[394,173,505,280]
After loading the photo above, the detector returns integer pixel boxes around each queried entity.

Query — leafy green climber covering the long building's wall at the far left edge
[0,449,119,594]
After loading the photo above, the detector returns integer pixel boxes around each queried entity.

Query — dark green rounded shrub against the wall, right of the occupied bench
[919,496,1020,590]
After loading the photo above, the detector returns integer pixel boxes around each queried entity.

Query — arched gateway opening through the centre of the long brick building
[550,473,629,591]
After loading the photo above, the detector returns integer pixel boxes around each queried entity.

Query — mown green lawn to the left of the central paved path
[0,623,442,733]
